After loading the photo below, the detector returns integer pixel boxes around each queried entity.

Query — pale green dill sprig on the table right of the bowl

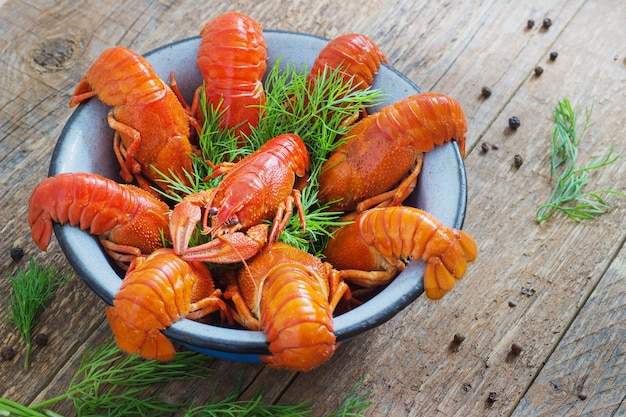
[536,98,626,223]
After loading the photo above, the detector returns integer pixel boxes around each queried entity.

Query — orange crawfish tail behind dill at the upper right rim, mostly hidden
[309,33,388,90]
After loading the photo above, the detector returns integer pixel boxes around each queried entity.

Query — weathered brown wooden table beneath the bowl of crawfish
[0,0,626,417]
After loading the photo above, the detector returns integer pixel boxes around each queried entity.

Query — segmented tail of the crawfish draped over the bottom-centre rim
[261,263,336,371]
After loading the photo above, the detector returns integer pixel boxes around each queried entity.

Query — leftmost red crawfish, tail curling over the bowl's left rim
[28,173,170,269]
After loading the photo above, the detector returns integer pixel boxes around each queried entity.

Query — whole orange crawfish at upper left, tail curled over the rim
[69,46,193,195]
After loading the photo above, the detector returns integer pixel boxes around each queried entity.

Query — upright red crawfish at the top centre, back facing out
[192,12,267,136]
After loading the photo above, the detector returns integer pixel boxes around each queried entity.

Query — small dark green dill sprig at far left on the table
[2,259,70,369]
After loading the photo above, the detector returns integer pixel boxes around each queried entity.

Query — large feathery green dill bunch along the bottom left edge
[0,338,370,417]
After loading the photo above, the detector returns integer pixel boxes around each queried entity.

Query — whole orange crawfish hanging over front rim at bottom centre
[224,242,347,371]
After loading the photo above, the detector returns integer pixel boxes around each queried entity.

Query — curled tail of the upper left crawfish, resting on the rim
[70,46,166,107]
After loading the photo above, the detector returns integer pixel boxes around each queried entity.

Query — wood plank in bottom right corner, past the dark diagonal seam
[512,247,626,417]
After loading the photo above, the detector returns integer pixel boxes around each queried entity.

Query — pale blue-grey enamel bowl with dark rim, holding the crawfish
[49,30,467,362]
